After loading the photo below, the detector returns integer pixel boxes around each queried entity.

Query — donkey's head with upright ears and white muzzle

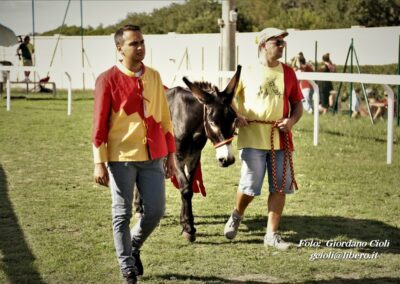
[183,65,241,167]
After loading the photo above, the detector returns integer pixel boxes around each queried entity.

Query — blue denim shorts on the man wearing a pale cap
[239,148,294,196]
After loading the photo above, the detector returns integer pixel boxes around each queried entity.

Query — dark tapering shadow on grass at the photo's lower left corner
[0,165,44,283]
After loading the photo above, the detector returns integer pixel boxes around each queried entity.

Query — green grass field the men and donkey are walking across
[0,93,400,283]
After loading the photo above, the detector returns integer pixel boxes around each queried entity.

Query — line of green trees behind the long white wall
[41,0,400,35]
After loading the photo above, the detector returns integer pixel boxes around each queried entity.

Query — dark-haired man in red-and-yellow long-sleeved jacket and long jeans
[92,25,175,283]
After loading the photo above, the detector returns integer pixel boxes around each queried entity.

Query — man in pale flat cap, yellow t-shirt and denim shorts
[224,28,303,249]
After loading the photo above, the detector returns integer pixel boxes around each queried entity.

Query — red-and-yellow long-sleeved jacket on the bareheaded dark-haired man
[92,63,175,163]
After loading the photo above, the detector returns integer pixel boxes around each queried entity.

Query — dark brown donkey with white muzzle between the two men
[167,65,241,242]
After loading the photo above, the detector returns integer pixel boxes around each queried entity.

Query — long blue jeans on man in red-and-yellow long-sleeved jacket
[107,159,165,275]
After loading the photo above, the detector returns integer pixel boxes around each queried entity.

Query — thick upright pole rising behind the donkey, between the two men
[221,0,237,76]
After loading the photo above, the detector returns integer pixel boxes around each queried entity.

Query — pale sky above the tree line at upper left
[0,0,184,35]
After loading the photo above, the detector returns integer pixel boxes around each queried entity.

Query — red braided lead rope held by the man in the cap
[247,120,298,193]
